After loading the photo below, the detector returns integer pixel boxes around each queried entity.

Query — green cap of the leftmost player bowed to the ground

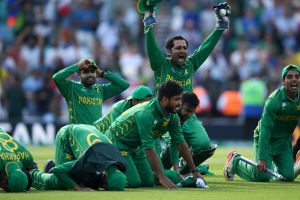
[5,162,28,192]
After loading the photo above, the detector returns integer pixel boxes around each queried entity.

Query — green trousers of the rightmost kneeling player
[233,138,294,182]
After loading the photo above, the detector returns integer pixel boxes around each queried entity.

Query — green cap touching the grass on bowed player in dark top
[106,166,126,191]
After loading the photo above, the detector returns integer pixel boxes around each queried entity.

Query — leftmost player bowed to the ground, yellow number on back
[0,128,34,192]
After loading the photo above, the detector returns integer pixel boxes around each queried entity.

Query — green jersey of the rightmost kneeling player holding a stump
[254,87,300,160]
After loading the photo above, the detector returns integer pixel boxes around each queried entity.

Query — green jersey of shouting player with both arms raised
[145,28,223,92]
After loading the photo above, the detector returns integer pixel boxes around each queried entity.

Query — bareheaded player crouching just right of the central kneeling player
[161,92,216,174]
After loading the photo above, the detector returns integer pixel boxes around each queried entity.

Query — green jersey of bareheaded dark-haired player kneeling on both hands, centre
[106,98,184,149]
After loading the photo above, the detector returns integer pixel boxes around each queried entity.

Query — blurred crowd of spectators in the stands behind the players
[0,0,300,123]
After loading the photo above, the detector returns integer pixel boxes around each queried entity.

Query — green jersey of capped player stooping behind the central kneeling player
[94,100,131,133]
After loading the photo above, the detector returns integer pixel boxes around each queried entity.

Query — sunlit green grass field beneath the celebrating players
[0,147,300,200]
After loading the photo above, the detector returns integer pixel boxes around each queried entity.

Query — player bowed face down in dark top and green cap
[31,142,126,191]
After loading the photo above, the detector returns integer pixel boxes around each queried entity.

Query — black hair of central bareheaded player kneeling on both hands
[158,81,183,101]
